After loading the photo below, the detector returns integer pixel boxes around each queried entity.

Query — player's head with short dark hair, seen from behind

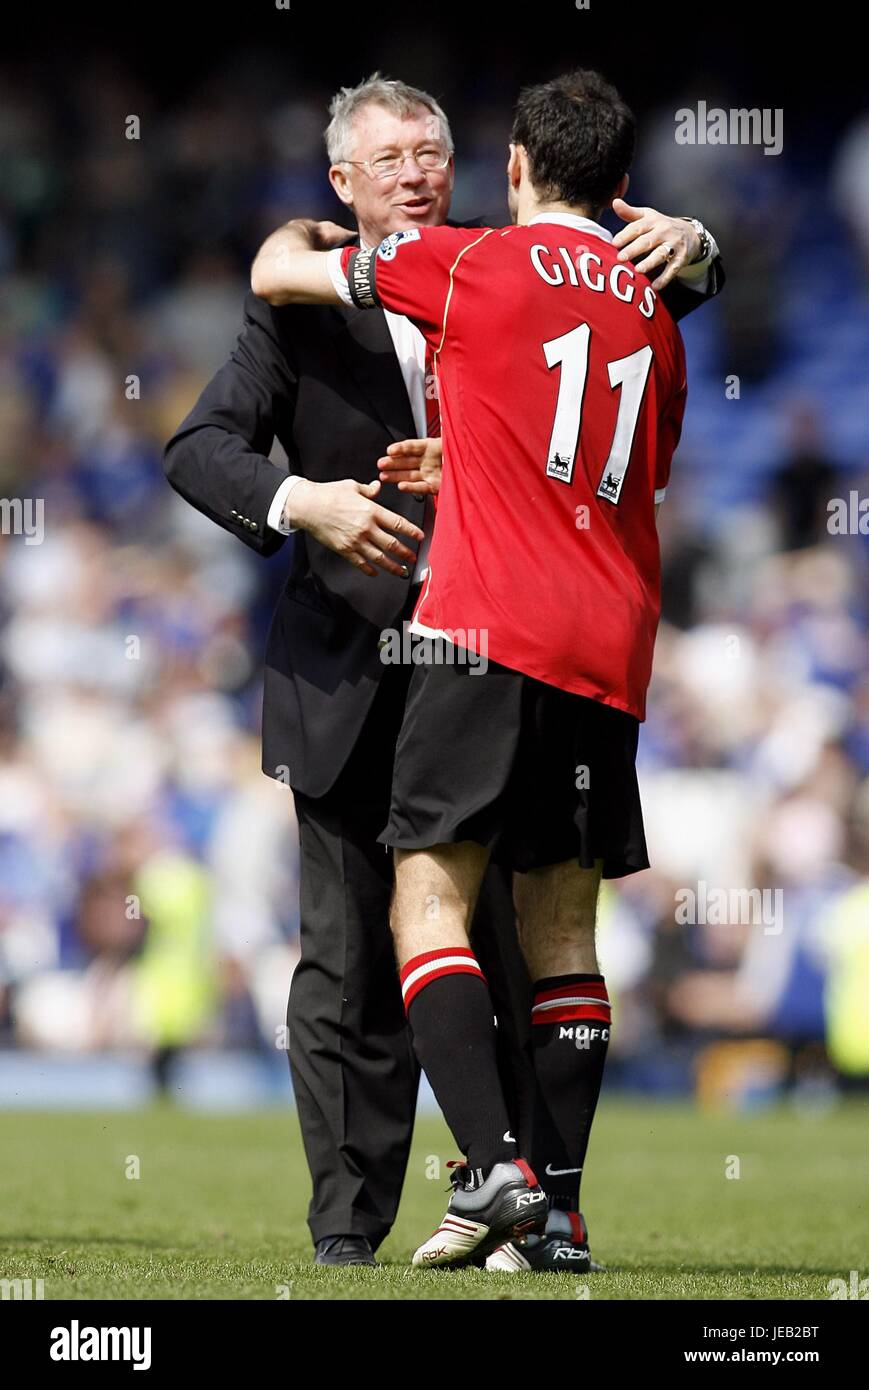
[510,68,637,214]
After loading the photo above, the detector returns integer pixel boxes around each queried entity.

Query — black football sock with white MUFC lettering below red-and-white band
[531,974,610,1212]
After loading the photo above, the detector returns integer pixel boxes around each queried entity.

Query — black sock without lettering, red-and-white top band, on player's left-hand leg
[402,948,519,1175]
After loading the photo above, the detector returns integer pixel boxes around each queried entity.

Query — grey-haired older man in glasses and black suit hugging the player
[165,75,720,1264]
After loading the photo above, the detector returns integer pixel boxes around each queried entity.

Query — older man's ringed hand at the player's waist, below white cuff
[288,478,424,578]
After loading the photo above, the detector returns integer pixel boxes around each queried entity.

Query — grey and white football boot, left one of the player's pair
[413,1159,546,1269]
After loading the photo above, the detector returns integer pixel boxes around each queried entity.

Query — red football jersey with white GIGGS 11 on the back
[341,215,685,719]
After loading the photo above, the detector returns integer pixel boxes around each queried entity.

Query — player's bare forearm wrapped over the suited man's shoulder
[250,217,355,307]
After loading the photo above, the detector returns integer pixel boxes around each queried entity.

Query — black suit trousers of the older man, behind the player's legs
[288,650,533,1248]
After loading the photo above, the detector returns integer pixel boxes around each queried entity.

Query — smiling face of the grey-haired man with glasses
[330,103,453,246]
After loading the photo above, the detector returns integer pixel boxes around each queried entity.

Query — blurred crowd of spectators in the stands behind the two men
[0,53,869,1099]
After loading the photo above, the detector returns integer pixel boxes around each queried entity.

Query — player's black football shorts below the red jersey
[380,639,649,878]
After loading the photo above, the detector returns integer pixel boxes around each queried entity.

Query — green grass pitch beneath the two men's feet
[0,1101,869,1300]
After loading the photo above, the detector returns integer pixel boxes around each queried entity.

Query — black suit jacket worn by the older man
[165,260,724,796]
